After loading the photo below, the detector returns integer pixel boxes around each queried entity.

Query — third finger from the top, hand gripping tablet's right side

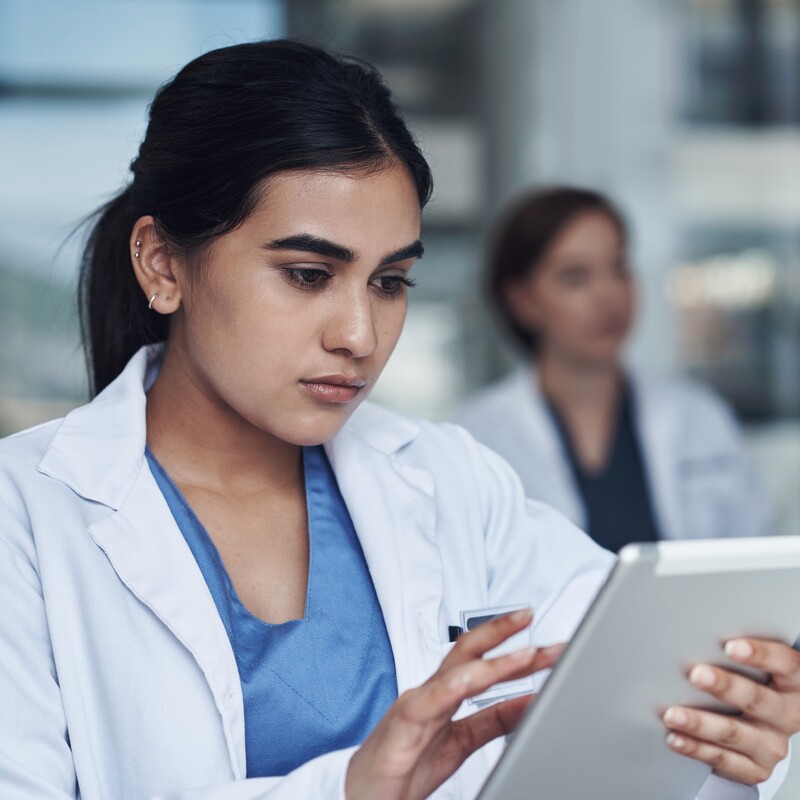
[662,706,788,769]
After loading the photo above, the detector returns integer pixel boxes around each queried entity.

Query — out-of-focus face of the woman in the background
[506,211,635,366]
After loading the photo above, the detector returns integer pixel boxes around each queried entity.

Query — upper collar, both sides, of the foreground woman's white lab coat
[39,345,420,510]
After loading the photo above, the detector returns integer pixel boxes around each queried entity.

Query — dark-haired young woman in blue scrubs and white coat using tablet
[0,42,800,800]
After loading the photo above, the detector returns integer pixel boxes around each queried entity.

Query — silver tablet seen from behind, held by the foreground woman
[479,536,800,800]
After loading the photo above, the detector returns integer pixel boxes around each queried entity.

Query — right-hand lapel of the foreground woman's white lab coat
[326,412,450,692]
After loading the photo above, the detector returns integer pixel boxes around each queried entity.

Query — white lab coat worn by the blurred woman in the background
[454,369,776,539]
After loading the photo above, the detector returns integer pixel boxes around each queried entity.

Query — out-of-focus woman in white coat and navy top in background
[456,188,774,551]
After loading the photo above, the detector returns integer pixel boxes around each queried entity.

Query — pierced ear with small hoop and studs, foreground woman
[129,215,182,314]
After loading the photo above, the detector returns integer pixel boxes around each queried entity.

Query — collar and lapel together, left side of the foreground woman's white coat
[39,345,245,777]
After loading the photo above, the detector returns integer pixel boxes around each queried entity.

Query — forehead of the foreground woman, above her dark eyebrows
[242,164,421,248]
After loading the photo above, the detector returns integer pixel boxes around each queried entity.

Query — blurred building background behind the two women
[0,0,800,798]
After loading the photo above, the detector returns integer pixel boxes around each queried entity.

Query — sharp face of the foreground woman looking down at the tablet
[170,166,422,445]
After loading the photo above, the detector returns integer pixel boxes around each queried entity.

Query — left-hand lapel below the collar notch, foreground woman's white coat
[89,464,246,778]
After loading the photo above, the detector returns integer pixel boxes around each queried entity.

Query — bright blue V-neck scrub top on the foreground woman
[147,447,397,777]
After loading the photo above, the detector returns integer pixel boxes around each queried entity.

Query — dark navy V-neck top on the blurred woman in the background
[550,385,659,553]
